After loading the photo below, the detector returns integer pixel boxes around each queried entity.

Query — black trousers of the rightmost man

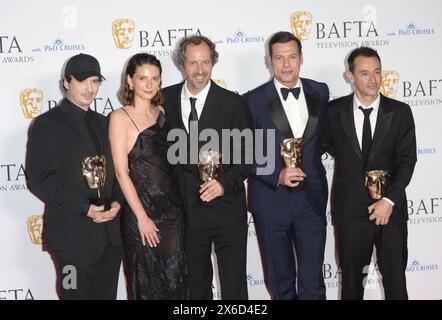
[337,211,408,300]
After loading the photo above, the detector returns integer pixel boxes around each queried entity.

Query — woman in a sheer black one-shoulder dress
[109,53,189,300]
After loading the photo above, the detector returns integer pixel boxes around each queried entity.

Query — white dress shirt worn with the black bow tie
[274,78,308,138]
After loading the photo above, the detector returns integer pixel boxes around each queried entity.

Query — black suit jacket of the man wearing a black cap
[26,99,122,250]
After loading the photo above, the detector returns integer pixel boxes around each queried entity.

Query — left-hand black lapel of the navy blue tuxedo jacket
[264,81,293,138]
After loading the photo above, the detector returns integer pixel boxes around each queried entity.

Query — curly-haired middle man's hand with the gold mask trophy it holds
[198,150,224,202]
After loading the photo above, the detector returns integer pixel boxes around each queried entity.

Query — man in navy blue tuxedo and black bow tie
[246,31,329,300]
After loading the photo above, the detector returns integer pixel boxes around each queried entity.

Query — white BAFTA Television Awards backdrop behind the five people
[0,0,442,300]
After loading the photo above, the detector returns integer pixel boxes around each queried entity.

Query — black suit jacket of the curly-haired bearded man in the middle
[164,81,252,228]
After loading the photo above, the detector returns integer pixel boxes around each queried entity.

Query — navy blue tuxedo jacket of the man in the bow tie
[245,78,329,220]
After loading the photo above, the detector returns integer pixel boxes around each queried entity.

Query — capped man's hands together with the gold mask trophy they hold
[81,155,120,223]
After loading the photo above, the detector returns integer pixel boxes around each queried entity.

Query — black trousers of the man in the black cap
[51,245,122,300]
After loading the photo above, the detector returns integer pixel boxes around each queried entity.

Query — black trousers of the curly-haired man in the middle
[186,224,248,300]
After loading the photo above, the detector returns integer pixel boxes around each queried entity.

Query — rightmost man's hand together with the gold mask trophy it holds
[364,170,393,225]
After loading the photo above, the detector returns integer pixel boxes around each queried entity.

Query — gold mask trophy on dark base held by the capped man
[81,155,111,210]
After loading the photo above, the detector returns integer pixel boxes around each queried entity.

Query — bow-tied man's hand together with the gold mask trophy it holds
[278,138,307,188]
